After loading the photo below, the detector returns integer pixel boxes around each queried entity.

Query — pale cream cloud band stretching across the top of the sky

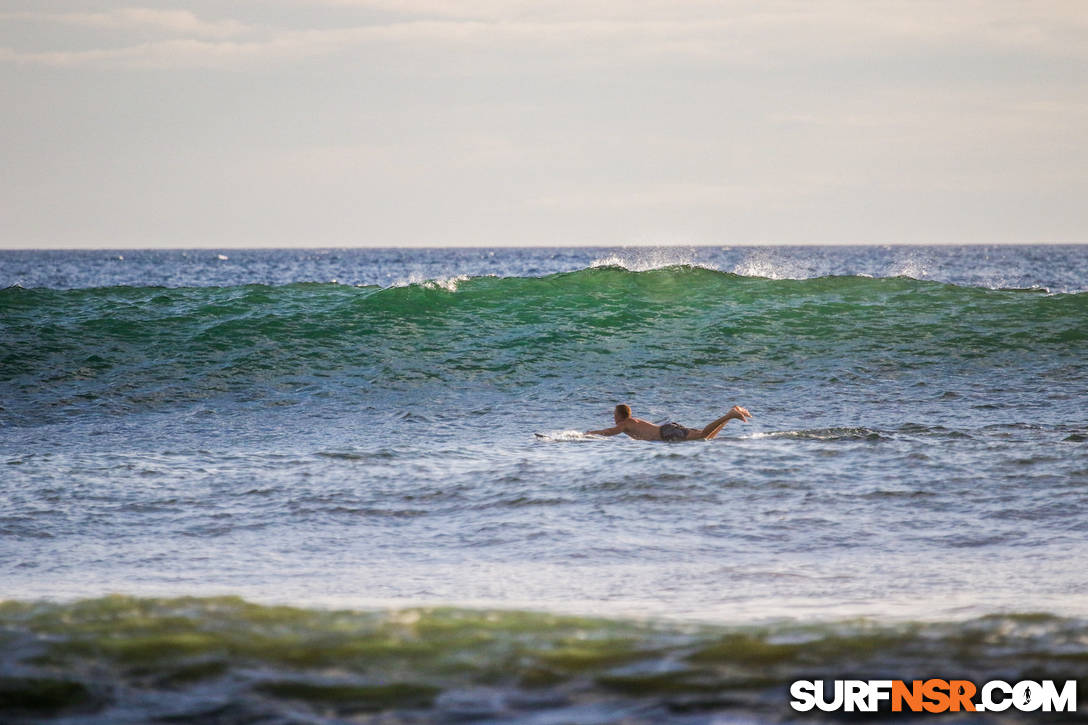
[0,0,1088,67]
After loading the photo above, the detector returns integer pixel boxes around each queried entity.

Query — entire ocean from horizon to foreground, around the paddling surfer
[0,245,1088,724]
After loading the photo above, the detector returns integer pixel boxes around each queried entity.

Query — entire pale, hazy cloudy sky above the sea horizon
[0,0,1088,248]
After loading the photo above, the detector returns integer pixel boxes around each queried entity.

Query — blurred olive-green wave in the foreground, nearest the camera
[0,597,1088,723]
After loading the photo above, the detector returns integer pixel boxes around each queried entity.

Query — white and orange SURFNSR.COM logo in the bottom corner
[790,679,1077,713]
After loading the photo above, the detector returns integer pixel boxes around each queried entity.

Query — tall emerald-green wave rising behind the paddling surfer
[0,267,1088,425]
